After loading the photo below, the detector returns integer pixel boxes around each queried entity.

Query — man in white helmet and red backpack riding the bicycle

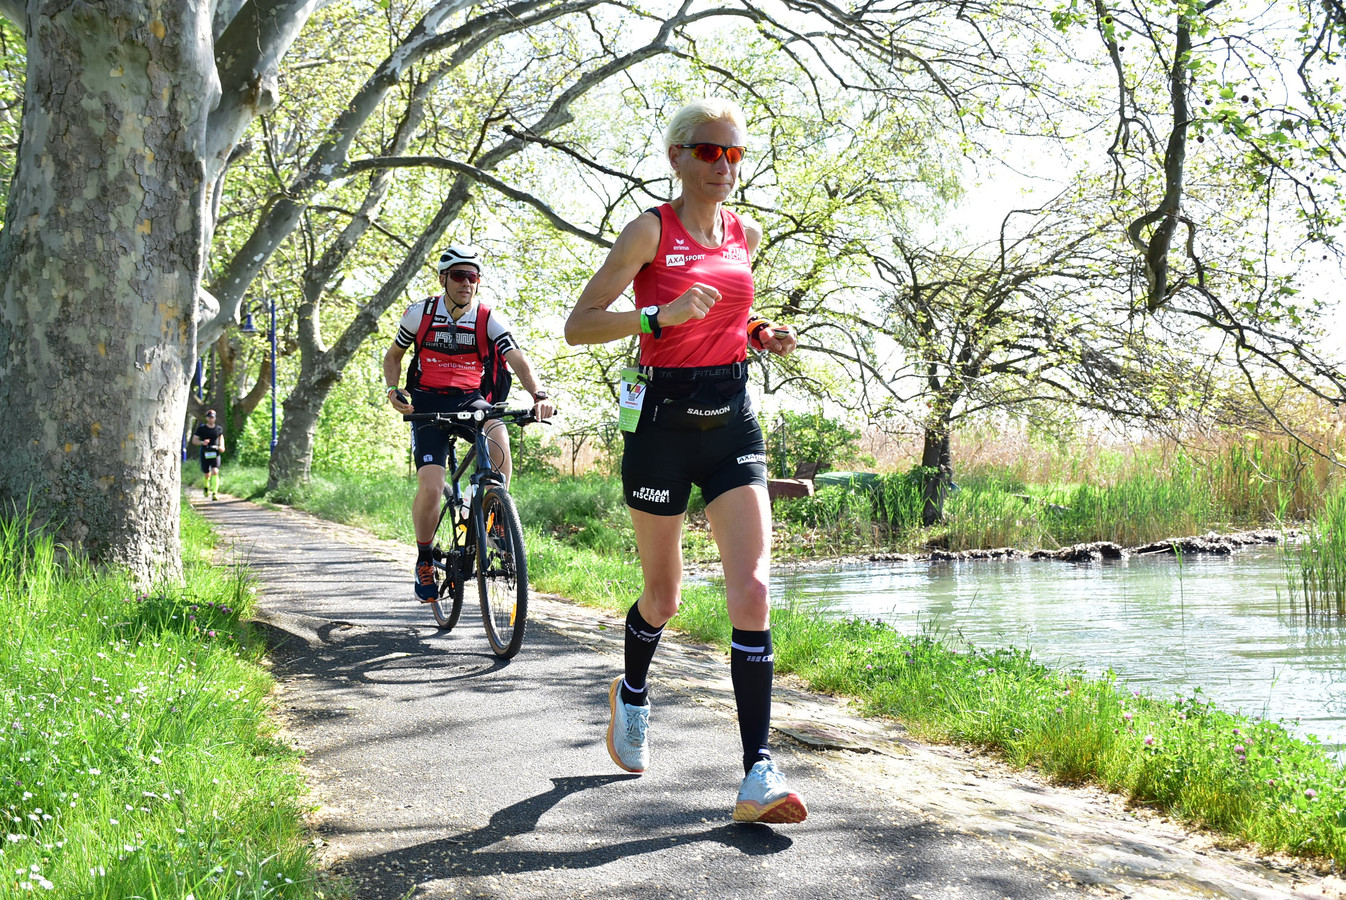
[384,245,555,603]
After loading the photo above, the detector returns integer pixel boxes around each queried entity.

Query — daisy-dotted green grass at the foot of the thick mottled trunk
[0,510,322,900]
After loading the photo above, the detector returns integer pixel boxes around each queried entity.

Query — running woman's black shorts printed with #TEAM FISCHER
[622,383,766,515]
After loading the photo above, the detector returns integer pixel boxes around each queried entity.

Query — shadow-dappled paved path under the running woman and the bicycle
[194,499,1346,900]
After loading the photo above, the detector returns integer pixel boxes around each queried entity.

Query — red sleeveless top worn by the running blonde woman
[633,203,752,367]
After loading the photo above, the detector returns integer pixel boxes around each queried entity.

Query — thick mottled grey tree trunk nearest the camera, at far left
[0,0,219,584]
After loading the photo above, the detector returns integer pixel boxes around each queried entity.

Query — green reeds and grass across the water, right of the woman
[775,436,1339,553]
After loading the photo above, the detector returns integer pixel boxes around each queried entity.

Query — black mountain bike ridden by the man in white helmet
[402,406,537,659]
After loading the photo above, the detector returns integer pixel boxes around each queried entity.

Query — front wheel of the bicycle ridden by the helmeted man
[476,484,528,659]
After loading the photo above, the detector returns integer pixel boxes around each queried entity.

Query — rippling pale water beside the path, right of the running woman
[771,548,1346,756]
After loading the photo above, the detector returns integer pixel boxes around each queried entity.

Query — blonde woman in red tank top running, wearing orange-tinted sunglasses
[565,100,808,822]
